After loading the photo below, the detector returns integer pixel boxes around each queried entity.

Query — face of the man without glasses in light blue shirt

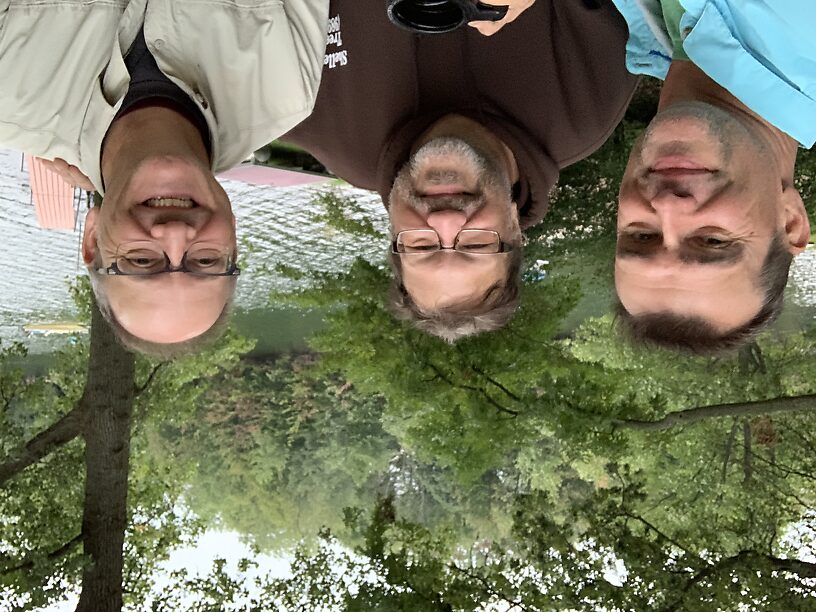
[615,102,796,333]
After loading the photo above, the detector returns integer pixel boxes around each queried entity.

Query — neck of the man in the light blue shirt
[657,60,799,186]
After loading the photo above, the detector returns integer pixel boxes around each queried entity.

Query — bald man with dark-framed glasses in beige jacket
[0,0,328,357]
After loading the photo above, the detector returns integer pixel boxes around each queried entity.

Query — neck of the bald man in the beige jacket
[102,106,209,190]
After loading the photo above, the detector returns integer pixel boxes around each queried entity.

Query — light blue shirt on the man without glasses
[613,0,816,148]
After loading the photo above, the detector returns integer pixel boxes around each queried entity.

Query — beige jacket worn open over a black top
[0,0,329,188]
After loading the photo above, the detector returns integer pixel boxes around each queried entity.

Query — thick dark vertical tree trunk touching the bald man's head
[77,305,135,612]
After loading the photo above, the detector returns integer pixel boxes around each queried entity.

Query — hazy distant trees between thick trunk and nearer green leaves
[161,356,398,550]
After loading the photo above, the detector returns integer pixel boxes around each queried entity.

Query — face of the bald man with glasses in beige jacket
[83,157,235,343]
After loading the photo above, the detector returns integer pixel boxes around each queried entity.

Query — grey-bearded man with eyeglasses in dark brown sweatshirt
[285,0,636,341]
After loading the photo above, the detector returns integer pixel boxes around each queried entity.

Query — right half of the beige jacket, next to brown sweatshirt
[145,0,329,170]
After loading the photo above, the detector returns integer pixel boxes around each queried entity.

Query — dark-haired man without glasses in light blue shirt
[614,0,816,352]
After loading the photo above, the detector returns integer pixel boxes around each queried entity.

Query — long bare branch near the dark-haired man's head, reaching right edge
[615,395,816,431]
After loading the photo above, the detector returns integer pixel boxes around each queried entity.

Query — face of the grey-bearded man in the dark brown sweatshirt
[388,137,520,310]
